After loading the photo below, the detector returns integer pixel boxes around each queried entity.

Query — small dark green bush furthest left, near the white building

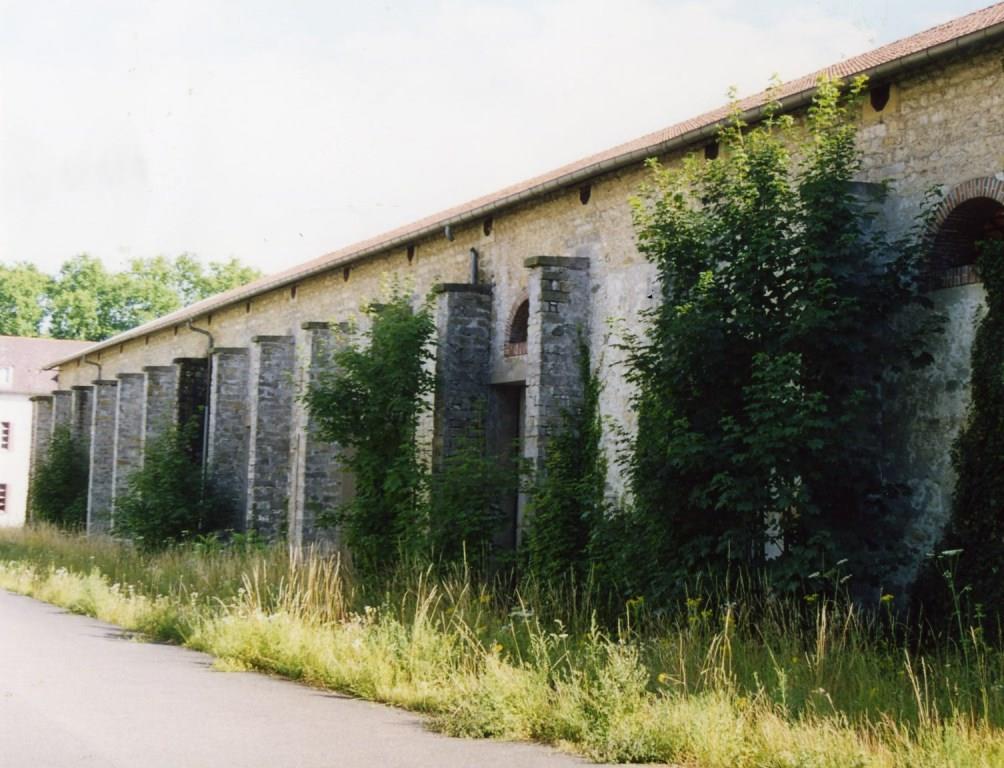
[28,426,88,530]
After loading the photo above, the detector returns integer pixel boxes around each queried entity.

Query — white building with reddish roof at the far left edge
[0,336,90,527]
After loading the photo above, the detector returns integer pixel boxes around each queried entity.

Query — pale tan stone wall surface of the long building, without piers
[52,38,1004,574]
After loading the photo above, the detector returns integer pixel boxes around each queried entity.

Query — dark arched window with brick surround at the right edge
[931,197,1004,288]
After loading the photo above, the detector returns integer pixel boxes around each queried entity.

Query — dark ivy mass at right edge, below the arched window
[920,241,1004,641]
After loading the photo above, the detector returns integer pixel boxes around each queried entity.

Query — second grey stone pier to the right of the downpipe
[246,336,295,538]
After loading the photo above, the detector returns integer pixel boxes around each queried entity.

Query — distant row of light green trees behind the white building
[0,254,261,341]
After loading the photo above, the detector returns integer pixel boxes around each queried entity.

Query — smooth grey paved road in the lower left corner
[0,589,598,768]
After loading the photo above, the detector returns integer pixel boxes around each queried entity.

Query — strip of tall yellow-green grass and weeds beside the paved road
[0,528,1004,768]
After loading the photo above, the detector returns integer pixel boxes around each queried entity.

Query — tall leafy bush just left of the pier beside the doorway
[306,287,436,573]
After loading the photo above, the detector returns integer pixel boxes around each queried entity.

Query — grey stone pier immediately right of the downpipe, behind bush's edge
[206,347,250,530]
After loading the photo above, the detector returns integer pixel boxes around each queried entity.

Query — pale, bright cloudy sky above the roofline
[0,0,989,273]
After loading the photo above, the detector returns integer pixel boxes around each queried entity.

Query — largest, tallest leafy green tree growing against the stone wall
[626,81,929,599]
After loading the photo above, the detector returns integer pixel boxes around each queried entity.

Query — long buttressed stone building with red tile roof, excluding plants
[36,4,1004,582]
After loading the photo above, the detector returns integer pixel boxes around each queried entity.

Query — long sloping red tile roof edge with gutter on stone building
[45,2,1004,366]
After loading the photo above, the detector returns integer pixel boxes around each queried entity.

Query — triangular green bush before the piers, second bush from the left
[114,422,233,549]
